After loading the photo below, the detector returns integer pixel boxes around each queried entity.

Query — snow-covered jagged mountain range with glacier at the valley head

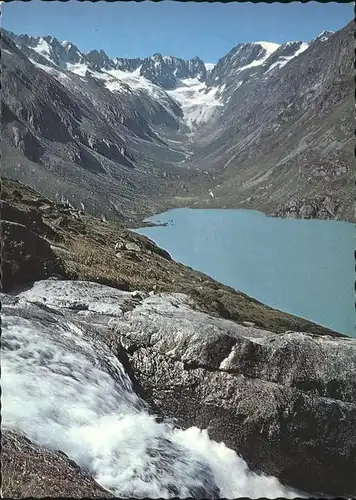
[4,29,316,131]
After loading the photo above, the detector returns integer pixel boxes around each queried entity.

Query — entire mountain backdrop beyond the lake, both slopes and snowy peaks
[2,23,354,220]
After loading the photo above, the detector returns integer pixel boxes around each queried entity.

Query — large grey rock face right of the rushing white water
[10,281,356,496]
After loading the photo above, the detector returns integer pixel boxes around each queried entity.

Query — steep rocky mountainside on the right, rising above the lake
[191,23,354,220]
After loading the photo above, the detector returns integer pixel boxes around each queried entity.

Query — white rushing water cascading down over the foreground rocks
[2,283,302,498]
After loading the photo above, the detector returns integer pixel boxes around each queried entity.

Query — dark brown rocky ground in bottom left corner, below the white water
[1,429,113,498]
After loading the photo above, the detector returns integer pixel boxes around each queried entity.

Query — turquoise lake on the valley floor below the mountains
[136,209,356,336]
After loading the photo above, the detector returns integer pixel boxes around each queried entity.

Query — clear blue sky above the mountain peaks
[2,0,353,62]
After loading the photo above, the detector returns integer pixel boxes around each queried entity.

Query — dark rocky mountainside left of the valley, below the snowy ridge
[2,28,202,218]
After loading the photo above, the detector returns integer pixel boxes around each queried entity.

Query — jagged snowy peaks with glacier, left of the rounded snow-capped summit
[5,29,221,130]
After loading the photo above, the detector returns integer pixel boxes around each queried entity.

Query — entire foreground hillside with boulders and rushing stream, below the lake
[1,180,356,498]
